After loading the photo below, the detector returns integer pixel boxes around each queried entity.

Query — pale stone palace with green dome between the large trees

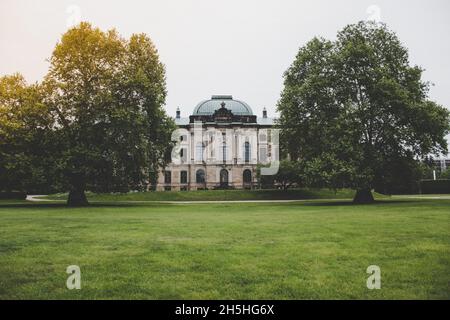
[157,95,278,190]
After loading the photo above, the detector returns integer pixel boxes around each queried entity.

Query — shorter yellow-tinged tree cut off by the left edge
[0,74,53,192]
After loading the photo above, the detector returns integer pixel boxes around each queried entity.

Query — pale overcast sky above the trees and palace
[0,0,450,127]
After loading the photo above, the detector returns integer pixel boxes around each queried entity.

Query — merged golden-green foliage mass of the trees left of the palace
[0,23,174,202]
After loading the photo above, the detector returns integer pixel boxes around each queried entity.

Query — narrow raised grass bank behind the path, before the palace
[41,189,372,201]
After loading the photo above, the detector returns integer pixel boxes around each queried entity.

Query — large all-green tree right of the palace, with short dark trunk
[278,22,450,202]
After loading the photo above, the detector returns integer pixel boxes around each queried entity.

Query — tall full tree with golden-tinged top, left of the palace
[43,22,174,205]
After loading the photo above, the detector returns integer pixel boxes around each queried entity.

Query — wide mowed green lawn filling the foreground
[0,199,450,299]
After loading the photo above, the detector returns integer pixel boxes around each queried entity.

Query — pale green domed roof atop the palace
[193,96,253,116]
